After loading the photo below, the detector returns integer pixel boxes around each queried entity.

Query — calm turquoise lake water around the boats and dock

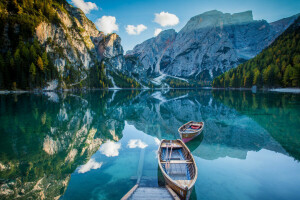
[0,90,300,199]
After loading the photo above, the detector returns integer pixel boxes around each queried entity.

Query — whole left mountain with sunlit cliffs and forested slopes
[0,0,138,90]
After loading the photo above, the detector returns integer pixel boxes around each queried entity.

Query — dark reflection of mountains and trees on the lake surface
[0,90,300,199]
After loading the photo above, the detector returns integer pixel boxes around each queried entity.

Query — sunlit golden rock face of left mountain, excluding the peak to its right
[36,6,98,73]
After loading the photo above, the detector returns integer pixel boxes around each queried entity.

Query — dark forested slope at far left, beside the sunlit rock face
[0,0,64,89]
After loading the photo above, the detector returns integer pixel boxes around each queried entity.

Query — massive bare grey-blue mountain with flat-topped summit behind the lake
[126,10,296,86]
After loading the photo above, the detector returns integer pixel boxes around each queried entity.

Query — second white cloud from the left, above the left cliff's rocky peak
[95,16,119,34]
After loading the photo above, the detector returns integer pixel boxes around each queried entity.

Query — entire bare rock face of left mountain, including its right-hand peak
[36,4,125,86]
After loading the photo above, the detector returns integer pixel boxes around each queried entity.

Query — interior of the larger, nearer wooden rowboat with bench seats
[160,141,195,185]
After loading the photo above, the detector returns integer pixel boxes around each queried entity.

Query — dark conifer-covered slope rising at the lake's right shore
[213,17,300,88]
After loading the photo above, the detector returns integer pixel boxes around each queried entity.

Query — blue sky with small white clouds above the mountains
[67,0,300,53]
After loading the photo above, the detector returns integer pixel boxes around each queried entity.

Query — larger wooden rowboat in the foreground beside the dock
[157,140,198,199]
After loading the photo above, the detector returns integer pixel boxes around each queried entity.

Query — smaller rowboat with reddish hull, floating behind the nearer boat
[178,121,204,143]
